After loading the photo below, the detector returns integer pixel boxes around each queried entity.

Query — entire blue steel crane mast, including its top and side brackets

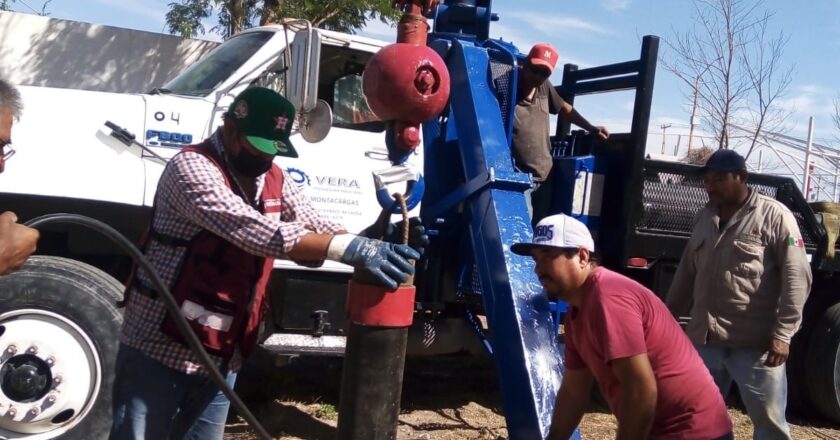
[421,0,579,439]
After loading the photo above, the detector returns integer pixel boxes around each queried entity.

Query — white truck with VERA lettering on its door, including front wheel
[0,21,466,440]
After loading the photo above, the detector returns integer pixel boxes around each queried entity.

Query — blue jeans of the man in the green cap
[110,345,236,440]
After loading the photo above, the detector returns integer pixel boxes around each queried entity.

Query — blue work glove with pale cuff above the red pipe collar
[339,237,420,289]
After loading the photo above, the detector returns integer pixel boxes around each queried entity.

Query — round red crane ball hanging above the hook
[362,43,449,125]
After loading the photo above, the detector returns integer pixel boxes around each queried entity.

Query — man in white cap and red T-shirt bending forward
[511,214,732,440]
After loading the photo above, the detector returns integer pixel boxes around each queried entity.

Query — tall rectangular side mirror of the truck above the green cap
[286,27,321,113]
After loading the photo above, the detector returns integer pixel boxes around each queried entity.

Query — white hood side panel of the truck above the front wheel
[0,86,143,206]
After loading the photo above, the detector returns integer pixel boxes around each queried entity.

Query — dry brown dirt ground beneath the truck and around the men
[225,356,840,440]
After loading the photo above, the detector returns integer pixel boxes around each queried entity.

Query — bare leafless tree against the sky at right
[662,0,792,155]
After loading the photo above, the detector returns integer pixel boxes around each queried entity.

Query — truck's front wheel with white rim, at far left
[0,256,123,440]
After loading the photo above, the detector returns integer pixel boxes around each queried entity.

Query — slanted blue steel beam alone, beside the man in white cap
[440,40,578,440]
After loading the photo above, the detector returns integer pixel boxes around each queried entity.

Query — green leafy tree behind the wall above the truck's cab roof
[166,0,400,37]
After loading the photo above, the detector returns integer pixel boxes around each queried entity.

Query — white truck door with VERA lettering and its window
[255,40,422,270]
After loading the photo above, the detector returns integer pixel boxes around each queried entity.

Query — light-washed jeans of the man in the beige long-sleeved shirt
[697,344,790,440]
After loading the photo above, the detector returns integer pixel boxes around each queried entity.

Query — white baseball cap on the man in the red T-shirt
[510,214,595,256]
